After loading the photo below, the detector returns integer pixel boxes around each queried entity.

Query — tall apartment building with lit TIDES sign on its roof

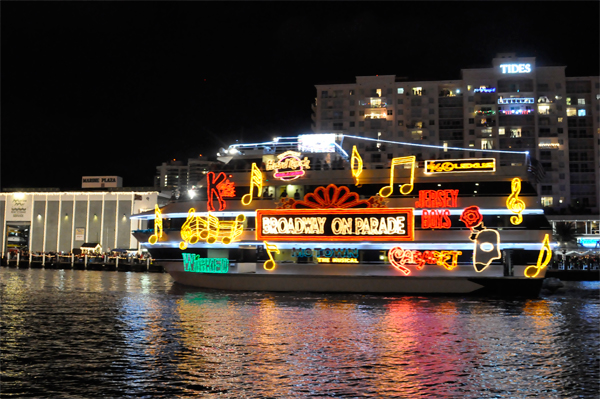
[312,53,600,214]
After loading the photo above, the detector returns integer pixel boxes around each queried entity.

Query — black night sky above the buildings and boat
[0,2,600,189]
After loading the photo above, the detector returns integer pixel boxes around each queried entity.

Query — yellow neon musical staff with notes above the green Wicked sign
[179,208,246,250]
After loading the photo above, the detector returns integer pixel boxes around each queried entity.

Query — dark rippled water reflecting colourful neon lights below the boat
[0,268,600,398]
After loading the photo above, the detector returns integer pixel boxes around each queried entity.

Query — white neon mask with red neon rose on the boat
[459,206,502,272]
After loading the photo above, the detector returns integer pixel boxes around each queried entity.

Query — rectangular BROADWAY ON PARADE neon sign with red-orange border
[256,208,414,241]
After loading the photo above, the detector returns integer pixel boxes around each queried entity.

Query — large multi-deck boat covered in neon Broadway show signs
[133,134,552,296]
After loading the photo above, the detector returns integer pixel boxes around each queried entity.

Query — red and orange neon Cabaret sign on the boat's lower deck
[388,247,462,276]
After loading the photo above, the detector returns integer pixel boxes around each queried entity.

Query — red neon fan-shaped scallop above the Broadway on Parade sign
[292,184,370,209]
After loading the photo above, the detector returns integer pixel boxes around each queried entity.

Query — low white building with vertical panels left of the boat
[0,189,158,254]
